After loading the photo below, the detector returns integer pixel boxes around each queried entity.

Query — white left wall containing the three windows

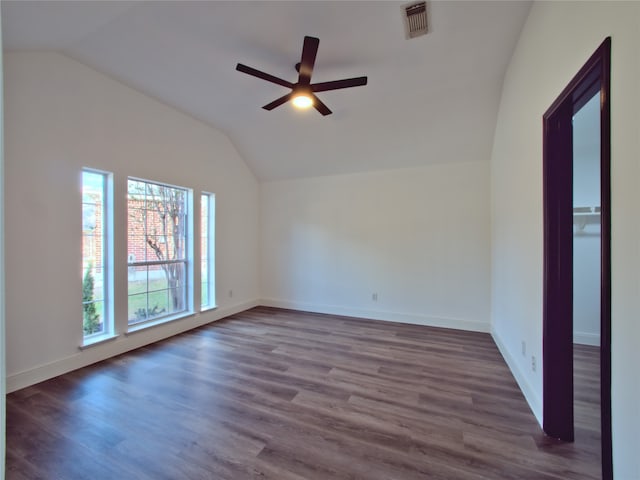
[4,52,259,391]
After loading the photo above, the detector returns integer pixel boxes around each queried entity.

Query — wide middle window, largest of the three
[127,179,191,326]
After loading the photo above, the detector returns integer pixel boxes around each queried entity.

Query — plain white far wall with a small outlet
[261,162,490,331]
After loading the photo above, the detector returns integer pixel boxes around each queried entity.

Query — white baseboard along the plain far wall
[260,298,490,333]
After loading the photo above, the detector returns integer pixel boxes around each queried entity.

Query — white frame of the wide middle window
[126,176,194,333]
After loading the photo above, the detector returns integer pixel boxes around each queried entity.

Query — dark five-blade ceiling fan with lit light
[236,37,367,115]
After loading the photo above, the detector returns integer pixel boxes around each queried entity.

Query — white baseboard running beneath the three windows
[6,299,260,393]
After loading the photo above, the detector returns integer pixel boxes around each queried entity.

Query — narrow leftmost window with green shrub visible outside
[82,170,113,344]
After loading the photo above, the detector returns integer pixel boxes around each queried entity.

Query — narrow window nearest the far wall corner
[200,193,216,309]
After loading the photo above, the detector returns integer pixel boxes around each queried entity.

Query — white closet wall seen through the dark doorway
[573,93,601,345]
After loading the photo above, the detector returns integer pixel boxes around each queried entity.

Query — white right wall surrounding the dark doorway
[491,2,640,480]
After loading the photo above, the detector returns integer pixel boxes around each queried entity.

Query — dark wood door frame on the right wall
[542,37,613,480]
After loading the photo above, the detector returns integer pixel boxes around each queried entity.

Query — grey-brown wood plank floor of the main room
[7,308,600,480]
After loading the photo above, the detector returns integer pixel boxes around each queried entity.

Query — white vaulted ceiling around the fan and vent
[2,0,531,180]
